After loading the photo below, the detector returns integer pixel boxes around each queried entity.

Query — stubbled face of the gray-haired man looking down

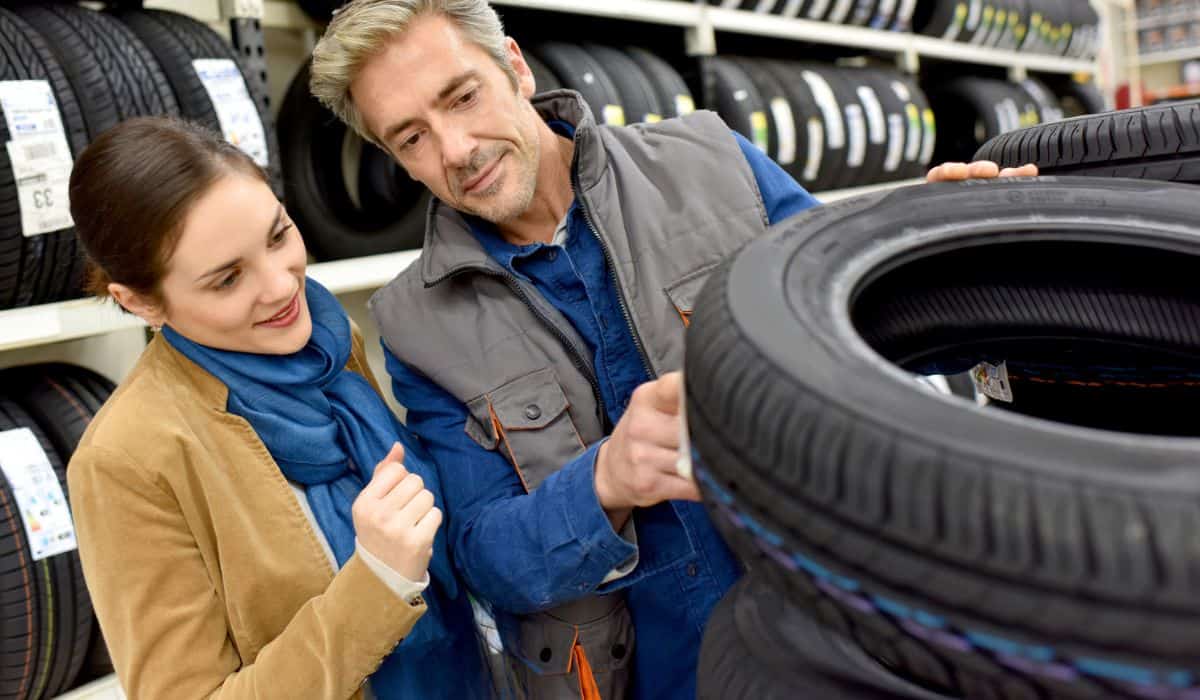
[350,14,540,223]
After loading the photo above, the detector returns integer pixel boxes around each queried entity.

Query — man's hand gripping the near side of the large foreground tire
[595,372,700,530]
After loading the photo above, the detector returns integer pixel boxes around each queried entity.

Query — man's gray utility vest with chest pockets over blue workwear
[370,90,767,700]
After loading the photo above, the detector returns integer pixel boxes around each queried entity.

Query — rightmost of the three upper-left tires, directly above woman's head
[116,10,283,198]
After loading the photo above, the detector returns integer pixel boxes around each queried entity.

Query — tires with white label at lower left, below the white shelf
[0,365,113,700]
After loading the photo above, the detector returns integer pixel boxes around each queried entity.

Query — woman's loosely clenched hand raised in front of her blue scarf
[352,443,442,581]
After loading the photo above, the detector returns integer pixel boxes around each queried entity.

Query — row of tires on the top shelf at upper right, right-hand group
[912,0,1100,59]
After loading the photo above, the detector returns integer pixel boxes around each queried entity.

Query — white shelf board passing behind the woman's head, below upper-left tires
[0,250,421,352]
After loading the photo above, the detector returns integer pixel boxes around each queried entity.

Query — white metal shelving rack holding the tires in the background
[0,0,1099,700]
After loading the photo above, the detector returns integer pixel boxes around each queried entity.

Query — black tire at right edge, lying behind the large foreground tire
[976,100,1200,183]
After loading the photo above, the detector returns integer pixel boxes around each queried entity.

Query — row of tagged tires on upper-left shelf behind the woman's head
[0,2,282,310]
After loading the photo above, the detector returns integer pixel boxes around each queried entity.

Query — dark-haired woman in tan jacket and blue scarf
[68,118,488,699]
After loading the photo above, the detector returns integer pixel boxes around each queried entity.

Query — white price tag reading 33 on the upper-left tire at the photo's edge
[0,80,74,237]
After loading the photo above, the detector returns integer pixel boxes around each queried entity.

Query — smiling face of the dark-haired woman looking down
[151,173,312,354]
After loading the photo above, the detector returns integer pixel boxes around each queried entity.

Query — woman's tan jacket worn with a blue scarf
[68,335,425,700]
